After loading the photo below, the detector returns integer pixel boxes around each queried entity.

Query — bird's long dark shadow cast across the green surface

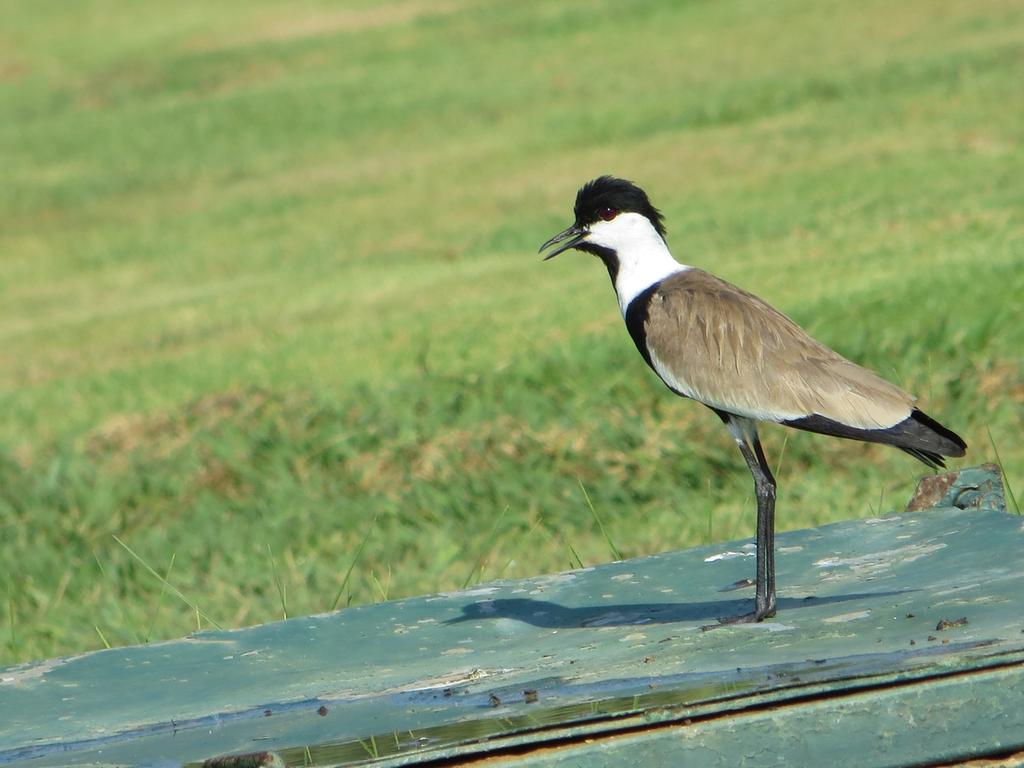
[444,590,907,629]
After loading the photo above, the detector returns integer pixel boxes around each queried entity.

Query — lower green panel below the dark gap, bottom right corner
[501,665,1024,768]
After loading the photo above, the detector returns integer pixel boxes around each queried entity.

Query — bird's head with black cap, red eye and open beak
[540,176,665,263]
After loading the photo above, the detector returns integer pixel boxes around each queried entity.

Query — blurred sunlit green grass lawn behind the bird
[0,0,1024,663]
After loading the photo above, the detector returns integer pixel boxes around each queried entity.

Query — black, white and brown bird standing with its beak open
[539,175,967,624]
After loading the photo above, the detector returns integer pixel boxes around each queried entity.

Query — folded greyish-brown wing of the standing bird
[644,268,913,429]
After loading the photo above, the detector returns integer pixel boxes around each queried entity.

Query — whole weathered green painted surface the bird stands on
[0,469,1024,766]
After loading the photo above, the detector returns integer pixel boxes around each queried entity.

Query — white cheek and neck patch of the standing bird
[587,213,690,317]
